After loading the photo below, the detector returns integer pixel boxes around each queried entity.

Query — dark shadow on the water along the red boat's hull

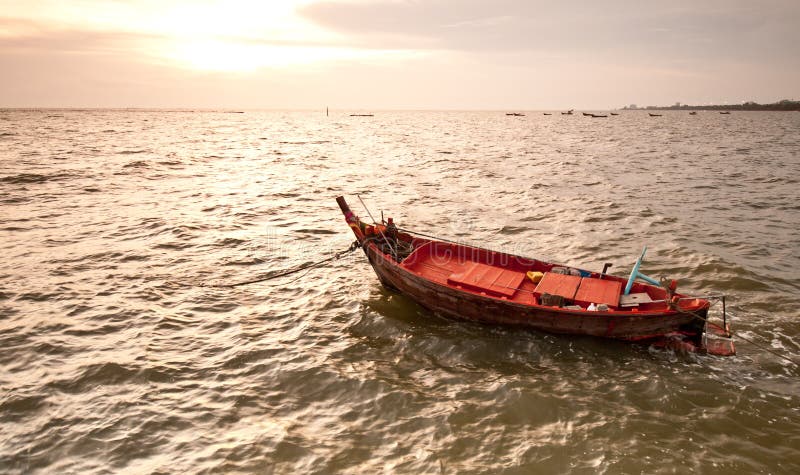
[347,282,704,374]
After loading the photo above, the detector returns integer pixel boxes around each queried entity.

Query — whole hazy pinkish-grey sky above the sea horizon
[0,0,800,110]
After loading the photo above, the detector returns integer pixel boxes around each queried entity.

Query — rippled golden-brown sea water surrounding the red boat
[0,110,800,474]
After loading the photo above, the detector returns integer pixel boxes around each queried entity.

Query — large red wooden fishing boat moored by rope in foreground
[336,196,735,355]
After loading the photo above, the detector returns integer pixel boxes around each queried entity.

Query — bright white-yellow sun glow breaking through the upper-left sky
[0,0,408,73]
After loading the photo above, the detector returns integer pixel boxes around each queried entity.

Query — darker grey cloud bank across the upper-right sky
[299,0,800,63]
